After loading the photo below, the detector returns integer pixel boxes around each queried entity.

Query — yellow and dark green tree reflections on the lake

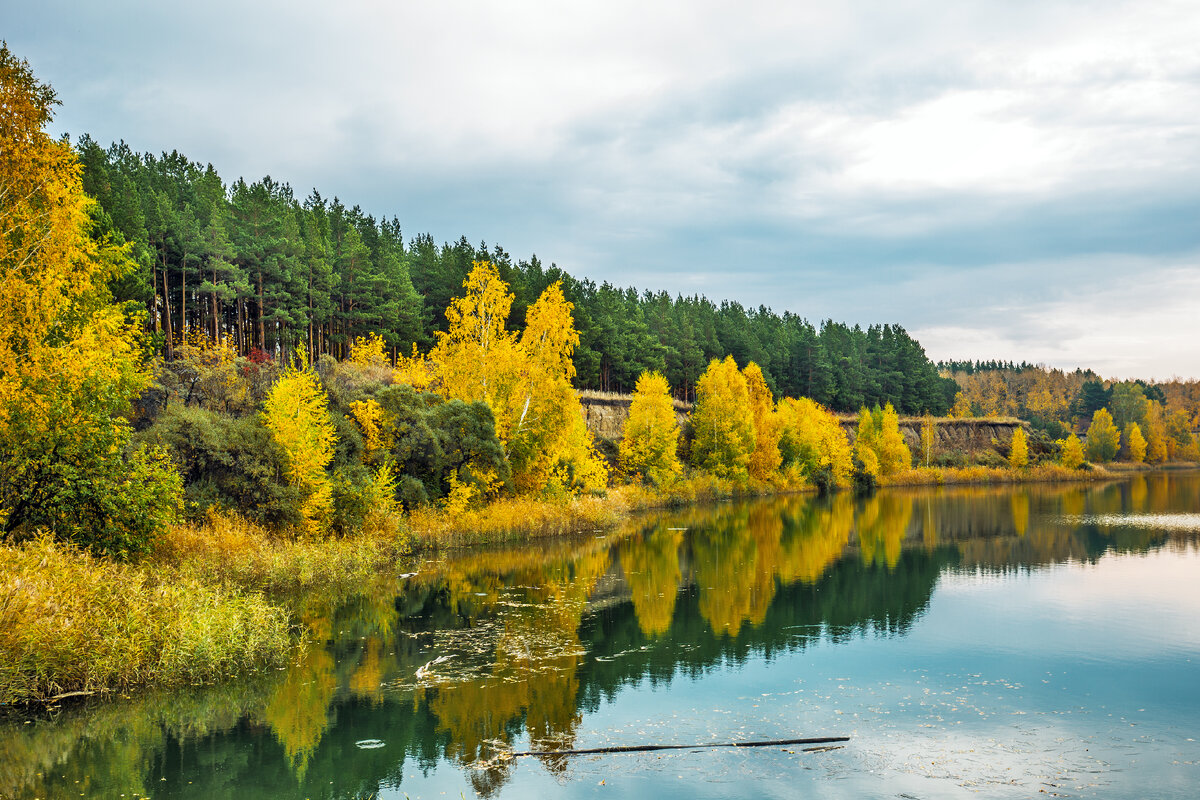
[0,474,1200,798]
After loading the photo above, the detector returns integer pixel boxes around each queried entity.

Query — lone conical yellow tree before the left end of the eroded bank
[618,372,680,486]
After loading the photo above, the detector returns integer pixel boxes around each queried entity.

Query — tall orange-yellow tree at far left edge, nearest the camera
[0,44,180,555]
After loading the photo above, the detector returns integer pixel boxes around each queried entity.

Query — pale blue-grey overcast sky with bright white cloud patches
[9,0,1200,378]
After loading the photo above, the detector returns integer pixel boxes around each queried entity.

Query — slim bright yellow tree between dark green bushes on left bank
[263,360,337,533]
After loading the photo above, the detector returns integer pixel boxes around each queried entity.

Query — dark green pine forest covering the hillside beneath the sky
[74,136,958,414]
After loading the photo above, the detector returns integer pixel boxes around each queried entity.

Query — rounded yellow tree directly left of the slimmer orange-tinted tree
[691,356,757,481]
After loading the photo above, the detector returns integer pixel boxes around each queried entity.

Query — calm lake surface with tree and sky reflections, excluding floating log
[0,474,1200,800]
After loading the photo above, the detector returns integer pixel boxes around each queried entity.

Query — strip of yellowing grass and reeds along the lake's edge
[0,465,1180,704]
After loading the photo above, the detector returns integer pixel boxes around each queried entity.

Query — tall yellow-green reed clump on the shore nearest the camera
[0,539,293,703]
